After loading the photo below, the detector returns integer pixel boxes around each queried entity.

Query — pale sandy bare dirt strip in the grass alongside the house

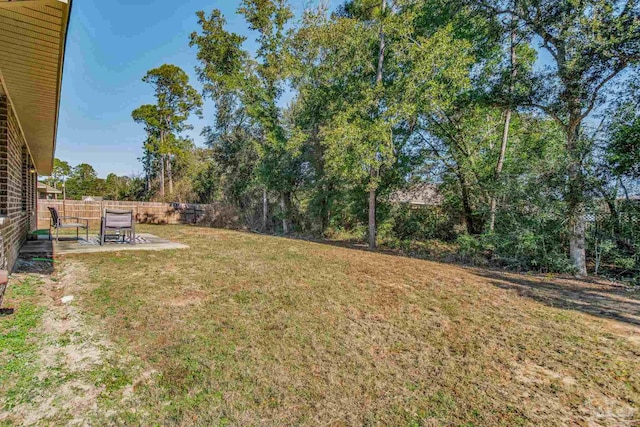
[0,261,158,425]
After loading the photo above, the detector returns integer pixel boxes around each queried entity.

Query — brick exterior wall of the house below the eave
[0,95,37,271]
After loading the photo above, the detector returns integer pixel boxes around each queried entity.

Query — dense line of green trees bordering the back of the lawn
[117,0,640,280]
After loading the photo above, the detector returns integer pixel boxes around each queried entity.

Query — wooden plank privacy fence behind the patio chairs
[38,199,211,229]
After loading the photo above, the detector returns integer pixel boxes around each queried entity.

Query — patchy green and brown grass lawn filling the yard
[0,226,640,426]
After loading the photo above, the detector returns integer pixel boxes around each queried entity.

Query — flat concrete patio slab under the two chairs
[20,233,188,260]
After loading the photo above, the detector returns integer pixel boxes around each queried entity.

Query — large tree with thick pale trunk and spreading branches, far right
[480,0,640,275]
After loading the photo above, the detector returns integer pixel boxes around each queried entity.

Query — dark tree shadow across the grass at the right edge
[474,270,640,326]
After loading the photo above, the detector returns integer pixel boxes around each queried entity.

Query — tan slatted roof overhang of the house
[0,0,71,175]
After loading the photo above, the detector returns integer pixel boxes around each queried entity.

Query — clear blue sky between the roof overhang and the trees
[56,0,338,177]
